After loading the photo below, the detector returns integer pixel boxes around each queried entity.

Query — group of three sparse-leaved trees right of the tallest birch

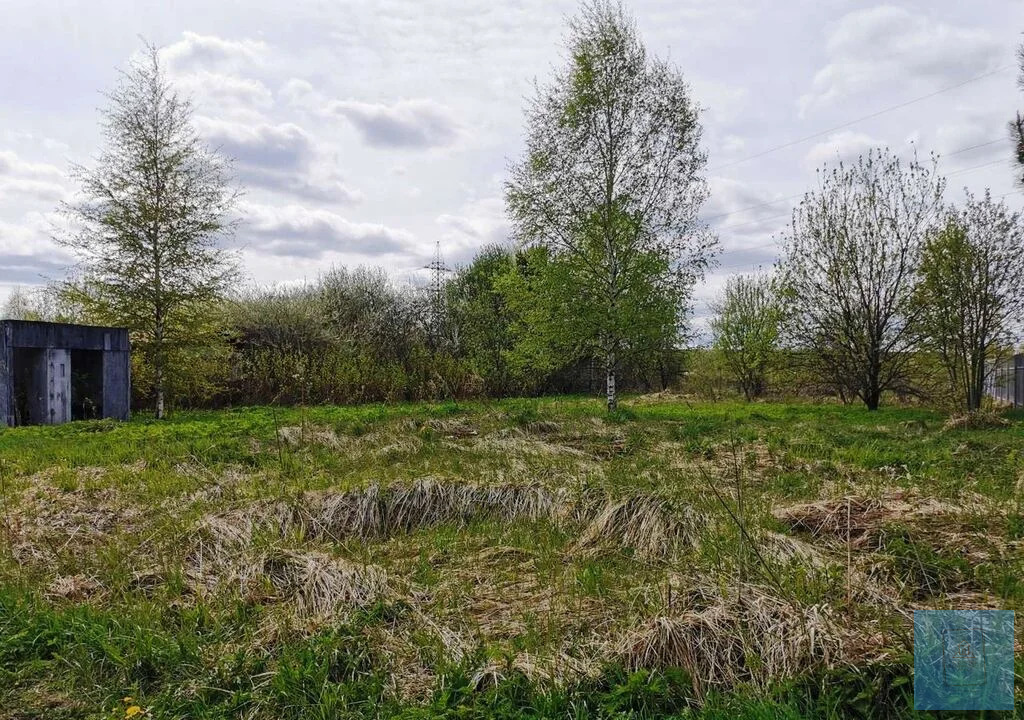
[712,150,1024,411]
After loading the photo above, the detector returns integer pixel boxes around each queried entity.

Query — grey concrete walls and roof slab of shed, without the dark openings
[0,321,131,425]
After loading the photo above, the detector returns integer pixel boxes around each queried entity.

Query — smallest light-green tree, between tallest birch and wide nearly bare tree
[711,274,782,400]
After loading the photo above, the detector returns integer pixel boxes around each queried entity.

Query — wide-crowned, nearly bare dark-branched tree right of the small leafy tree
[782,151,945,410]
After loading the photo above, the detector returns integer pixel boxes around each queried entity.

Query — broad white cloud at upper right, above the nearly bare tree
[799,5,1006,115]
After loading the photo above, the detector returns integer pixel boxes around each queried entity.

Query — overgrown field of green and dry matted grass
[0,396,1024,718]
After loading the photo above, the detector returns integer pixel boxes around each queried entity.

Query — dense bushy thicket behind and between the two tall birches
[6,246,683,408]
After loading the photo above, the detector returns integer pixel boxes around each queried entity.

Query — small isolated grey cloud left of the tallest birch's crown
[327,100,460,147]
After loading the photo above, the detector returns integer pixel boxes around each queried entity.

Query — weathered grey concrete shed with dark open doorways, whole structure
[0,320,131,425]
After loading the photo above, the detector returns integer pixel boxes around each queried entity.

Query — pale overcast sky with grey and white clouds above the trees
[0,0,1024,331]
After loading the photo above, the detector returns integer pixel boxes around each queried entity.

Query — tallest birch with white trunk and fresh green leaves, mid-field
[506,0,717,410]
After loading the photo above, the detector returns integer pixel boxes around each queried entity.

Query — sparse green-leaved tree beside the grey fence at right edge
[918,192,1024,411]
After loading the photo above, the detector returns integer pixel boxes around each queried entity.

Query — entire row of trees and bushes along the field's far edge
[7,0,1024,417]
